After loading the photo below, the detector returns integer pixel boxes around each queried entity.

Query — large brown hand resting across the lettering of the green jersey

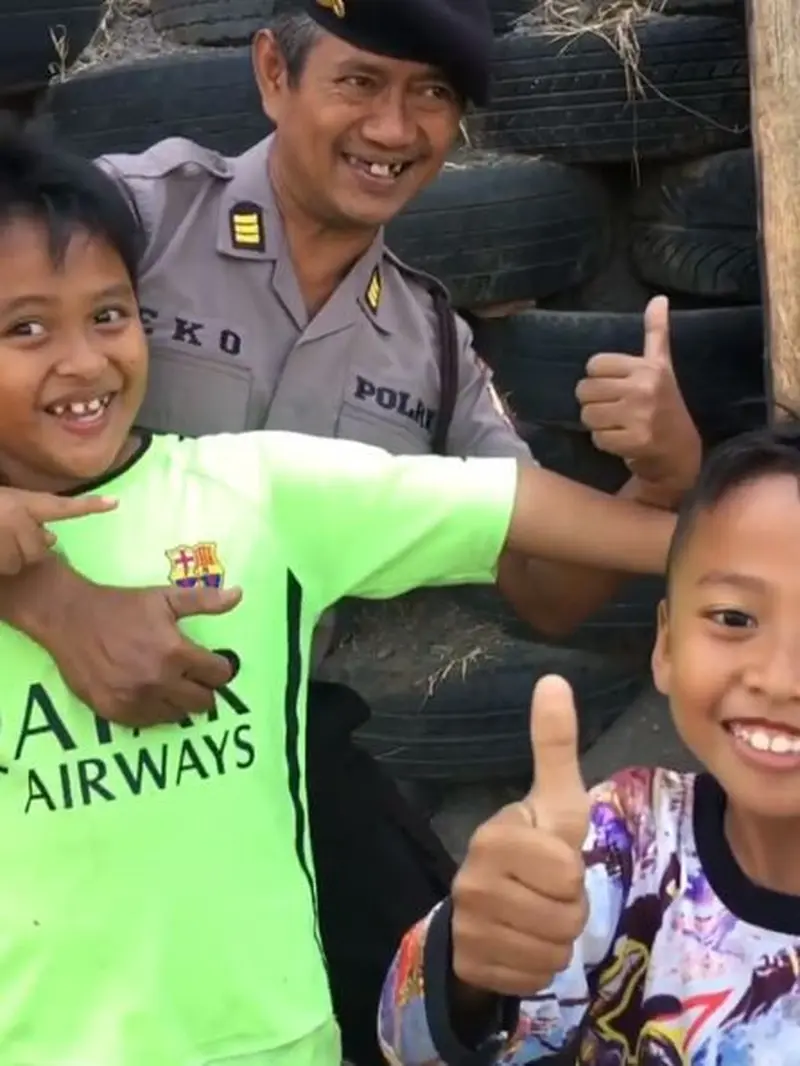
[0,556,241,726]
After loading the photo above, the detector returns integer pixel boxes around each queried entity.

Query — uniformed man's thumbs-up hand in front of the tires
[576,296,703,507]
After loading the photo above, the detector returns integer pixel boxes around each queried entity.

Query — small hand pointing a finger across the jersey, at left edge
[0,488,116,577]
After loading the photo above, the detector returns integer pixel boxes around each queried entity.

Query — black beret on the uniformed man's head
[306,0,493,104]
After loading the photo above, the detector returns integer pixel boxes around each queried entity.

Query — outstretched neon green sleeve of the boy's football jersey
[191,432,517,611]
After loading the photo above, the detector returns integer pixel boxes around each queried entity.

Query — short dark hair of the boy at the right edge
[667,423,800,585]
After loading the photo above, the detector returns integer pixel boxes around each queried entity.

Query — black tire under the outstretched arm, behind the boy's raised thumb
[336,589,650,784]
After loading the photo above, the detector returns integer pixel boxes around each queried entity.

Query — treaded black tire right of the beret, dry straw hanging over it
[467,15,750,163]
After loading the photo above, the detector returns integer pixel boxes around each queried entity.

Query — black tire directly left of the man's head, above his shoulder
[49,48,272,156]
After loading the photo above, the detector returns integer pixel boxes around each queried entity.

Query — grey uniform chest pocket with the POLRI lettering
[337,371,437,455]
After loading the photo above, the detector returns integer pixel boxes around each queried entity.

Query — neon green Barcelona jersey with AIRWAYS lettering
[0,433,516,1066]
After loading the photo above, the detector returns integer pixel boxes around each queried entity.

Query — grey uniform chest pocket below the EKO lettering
[139,352,257,437]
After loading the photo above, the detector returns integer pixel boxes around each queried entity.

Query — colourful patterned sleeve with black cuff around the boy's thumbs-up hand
[379,771,652,1066]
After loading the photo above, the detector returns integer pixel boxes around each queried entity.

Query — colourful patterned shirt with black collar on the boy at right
[379,770,800,1066]
